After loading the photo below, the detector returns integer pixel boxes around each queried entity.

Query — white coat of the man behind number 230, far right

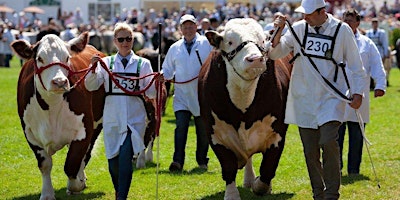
[345,31,386,123]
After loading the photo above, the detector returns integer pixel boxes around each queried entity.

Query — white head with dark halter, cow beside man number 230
[206,18,266,81]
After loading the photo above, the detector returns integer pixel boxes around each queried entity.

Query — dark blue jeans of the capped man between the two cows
[173,110,208,167]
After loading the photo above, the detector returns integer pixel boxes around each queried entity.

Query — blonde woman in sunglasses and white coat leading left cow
[85,23,156,200]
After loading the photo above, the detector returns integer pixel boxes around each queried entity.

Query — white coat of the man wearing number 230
[269,14,367,129]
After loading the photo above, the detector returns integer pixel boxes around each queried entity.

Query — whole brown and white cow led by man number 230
[199,19,290,199]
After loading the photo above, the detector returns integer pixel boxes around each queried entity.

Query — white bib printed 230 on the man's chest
[304,33,333,59]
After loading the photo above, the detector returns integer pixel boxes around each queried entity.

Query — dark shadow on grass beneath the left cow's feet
[12,188,105,200]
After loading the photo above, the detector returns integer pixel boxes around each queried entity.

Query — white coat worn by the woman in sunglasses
[85,52,156,159]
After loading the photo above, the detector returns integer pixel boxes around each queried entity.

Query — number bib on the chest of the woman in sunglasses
[109,72,140,95]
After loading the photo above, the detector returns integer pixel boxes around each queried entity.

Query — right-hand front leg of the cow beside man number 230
[252,135,285,195]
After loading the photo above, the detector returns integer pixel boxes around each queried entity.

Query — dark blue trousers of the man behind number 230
[338,122,365,174]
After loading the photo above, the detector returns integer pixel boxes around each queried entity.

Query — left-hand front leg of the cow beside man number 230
[211,144,240,200]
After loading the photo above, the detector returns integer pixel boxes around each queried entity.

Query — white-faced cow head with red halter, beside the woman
[11,32,89,94]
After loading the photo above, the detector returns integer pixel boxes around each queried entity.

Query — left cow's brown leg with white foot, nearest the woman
[64,138,90,194]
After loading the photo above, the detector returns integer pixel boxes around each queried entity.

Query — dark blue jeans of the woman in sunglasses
[108,128,133,200]
